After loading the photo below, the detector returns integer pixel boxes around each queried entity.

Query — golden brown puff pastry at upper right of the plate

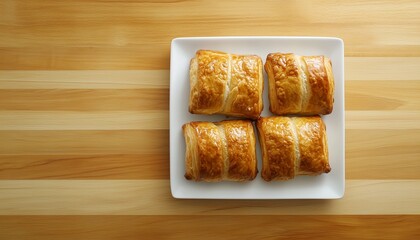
[264,53,334,115]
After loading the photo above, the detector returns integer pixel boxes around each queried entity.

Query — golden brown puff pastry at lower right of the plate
[257,116,331,181]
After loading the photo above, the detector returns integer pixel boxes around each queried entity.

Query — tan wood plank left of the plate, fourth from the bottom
[0,130,169,155]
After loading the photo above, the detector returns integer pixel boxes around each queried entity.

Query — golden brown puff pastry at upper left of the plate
[189,50,264,119]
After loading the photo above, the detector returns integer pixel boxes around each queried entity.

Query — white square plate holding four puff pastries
[170,37,345,199]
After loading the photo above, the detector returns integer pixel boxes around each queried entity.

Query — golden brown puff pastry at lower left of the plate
[182,120,258,182]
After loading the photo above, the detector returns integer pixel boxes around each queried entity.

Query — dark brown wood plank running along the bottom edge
[0,215,420,240]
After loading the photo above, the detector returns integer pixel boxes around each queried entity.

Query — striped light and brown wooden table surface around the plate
[0,0,420,239]
